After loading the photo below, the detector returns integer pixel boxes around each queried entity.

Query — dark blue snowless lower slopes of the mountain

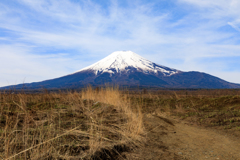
[3,71,240,89]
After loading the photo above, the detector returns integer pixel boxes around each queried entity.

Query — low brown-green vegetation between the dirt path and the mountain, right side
[131,90,240,135]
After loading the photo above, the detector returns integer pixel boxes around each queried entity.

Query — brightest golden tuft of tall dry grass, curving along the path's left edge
[82,86,144,140]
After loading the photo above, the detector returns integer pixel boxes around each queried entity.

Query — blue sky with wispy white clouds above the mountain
[0,0,240,86]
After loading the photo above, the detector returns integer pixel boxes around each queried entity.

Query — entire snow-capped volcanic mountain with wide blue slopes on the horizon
[1,51,240,89]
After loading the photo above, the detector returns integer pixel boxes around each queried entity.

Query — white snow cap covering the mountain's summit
[78,51,179,76]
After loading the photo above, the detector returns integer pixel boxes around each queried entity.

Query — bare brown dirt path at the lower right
[126,114,240,160]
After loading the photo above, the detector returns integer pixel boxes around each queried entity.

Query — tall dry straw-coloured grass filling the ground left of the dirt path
[0,87,144,160]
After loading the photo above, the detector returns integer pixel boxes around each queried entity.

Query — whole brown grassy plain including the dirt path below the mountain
[0,87,240,160]
